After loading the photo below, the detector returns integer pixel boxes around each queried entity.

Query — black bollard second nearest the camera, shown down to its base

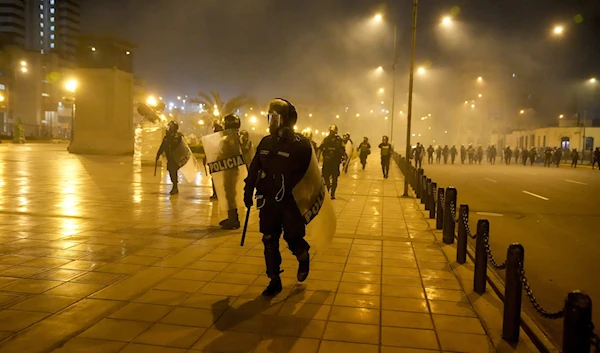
[502,244,524,340]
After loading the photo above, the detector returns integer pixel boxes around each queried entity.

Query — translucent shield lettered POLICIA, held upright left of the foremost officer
[202,129,248,211]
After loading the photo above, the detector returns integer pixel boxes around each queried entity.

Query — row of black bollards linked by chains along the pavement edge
[394,154,600,353]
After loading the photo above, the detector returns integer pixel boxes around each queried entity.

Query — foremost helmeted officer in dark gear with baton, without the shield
[244,99,313,296]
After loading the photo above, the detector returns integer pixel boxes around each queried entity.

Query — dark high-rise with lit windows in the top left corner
[0,0,81,61]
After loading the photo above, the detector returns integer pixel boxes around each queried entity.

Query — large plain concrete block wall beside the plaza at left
[69,69,134,155]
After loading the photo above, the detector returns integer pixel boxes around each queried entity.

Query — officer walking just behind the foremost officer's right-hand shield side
[319,125,346,200]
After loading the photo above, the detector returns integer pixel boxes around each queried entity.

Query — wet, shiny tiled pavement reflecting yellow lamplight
[0,145,502,353]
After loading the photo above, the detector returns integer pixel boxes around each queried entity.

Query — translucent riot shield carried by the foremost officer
[292,151,336,251]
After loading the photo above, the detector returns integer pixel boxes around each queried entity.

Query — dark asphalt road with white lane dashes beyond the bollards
[423,161,600,343]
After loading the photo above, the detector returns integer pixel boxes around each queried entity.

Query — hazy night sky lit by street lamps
[82,0,600,135]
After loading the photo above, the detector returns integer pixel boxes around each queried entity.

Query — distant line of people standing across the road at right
[409,143,600,169]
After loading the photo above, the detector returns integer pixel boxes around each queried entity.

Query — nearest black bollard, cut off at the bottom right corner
[562,291,592,353]
